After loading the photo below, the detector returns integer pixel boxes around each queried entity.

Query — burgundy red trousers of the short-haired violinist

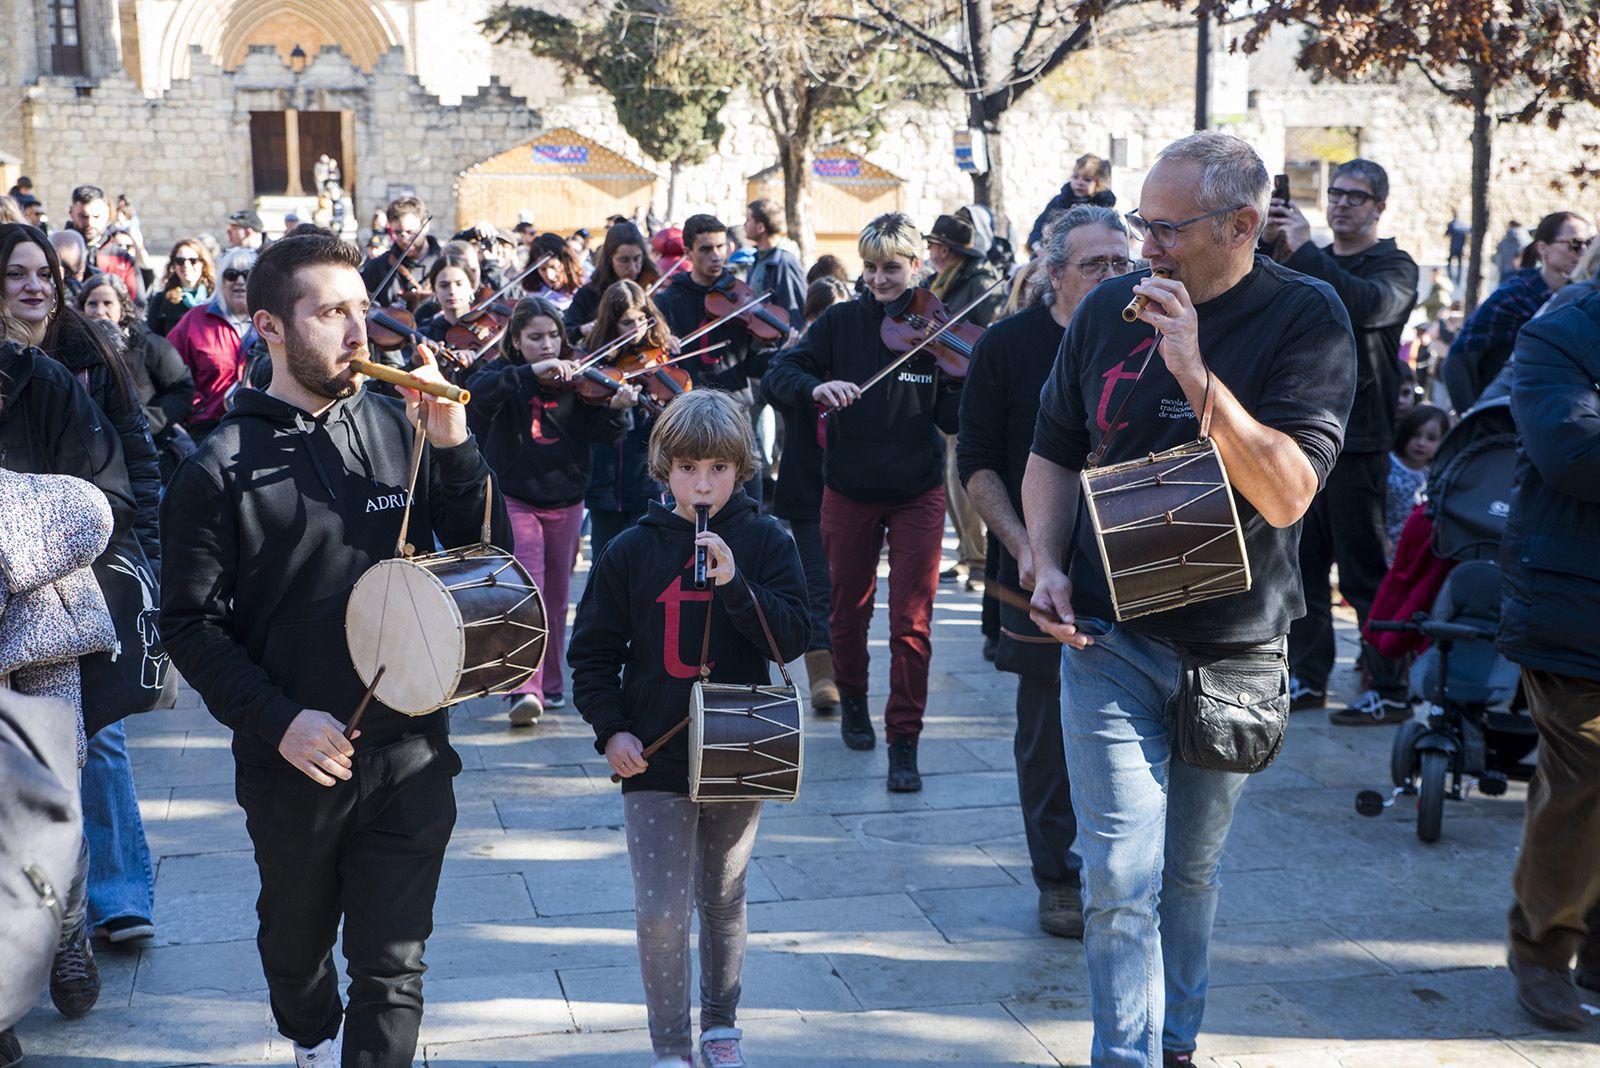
[822,486,944,742]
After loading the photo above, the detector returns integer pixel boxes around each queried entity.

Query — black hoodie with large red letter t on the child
[566,491,811,793]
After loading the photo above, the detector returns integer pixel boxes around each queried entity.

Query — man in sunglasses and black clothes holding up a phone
[1264,160,1419,726]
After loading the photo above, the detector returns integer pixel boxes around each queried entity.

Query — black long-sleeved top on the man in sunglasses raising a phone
[1285,238,1418,452]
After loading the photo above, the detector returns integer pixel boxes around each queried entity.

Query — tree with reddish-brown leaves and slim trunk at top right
[1203,0,1600,309]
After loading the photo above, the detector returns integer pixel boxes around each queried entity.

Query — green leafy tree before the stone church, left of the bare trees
[482,0,739,217]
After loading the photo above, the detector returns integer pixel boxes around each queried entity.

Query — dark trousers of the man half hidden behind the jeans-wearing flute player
[1013,675,1083,891]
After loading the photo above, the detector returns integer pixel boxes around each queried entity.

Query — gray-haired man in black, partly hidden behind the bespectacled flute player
[955,205,1133,938]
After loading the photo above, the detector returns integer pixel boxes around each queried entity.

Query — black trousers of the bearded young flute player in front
[235,737,461,1068]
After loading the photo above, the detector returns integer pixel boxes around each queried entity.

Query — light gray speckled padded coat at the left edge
[0,468,117,767]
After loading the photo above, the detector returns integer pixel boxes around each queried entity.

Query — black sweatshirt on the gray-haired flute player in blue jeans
[1034,256,1355,644]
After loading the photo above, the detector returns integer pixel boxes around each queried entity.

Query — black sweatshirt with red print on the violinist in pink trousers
[467,357,629,508]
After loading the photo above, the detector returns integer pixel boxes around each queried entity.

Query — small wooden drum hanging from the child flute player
[690,683,805,801]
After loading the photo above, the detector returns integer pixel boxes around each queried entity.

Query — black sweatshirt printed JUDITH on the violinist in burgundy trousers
[765,289,962,504]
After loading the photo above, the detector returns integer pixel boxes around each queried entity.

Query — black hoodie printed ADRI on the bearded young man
[162,389,512,766]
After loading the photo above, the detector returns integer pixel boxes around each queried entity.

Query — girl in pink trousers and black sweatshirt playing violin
[467,297,638,727]
